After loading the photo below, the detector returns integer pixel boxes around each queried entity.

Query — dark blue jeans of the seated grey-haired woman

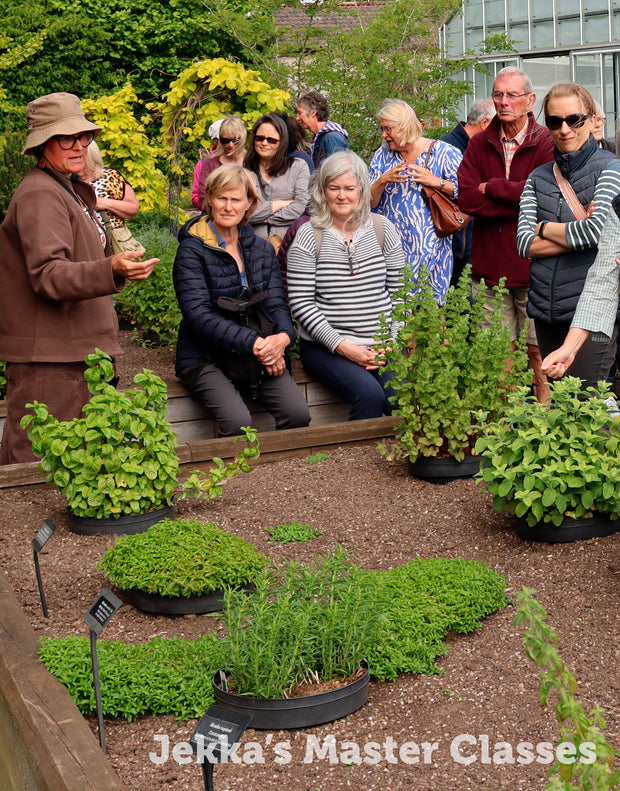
[299,338,394,420]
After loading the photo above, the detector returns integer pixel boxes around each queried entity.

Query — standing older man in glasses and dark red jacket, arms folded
[458,66,553,401]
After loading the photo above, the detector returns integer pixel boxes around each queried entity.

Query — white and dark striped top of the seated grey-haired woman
[287,218,405,352]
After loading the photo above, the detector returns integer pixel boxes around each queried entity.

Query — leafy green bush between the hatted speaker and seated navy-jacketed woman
[116,212,181,344]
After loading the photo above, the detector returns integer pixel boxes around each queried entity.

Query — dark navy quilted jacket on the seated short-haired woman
[172,215,295,373]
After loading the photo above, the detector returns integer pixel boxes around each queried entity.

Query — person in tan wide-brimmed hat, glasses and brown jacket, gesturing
[0,93,158,464]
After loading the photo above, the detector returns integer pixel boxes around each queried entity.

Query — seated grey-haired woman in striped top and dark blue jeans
[287,151,405,420]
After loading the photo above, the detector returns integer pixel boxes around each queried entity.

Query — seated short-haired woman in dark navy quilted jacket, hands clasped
[173,165,310,437]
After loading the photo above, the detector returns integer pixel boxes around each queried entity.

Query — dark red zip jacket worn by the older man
[458,112,553,288]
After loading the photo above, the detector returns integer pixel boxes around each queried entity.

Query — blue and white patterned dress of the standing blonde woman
[369,140,463,304]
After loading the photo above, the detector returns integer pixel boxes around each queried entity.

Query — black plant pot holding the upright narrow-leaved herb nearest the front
[211,668,369,731]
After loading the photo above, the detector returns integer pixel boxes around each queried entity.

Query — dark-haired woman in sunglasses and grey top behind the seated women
[243,113,310,252]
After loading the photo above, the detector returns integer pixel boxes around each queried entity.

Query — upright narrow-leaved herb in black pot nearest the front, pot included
[213,548,385,730]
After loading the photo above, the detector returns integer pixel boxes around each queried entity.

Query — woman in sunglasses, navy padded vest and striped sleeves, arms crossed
[517,83,620,388]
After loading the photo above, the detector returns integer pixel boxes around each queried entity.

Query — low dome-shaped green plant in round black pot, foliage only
[97,519,269,597]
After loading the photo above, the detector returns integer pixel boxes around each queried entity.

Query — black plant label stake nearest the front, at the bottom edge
[189,706,252,791]
